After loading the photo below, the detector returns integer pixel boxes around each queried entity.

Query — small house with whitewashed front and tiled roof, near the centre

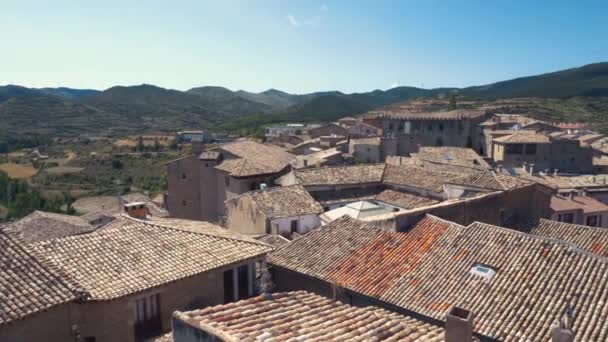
[226,185,323,239]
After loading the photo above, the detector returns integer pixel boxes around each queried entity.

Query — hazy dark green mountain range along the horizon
[0,63,608,138]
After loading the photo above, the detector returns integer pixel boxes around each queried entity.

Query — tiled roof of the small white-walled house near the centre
[227,185,323,218]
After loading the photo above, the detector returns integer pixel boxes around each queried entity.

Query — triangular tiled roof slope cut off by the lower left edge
[0,231,77,328]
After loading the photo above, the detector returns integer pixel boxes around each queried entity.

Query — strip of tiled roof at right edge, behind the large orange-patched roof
[506,219,608,257]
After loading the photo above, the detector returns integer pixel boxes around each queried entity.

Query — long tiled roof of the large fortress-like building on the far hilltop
[365,109,486,120]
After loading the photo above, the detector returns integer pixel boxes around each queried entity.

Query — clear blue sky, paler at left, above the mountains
[0,0,608,93]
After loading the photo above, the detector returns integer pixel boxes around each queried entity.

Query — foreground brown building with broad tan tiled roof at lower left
[0,215,272,342]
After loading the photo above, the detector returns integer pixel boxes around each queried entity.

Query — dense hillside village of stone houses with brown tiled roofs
[0,103,608,342]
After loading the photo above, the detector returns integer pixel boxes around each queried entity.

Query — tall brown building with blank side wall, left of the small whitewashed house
[166,141,295,222]
